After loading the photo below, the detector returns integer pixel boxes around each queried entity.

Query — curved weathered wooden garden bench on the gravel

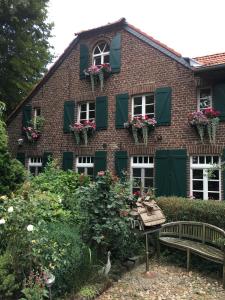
[159,221,225,288]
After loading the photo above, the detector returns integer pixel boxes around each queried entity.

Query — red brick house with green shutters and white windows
[5,19,225,200]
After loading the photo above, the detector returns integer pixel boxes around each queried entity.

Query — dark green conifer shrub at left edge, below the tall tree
[0,102,25,195]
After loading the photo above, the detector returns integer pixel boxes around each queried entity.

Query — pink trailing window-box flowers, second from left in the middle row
[70,120,96,145]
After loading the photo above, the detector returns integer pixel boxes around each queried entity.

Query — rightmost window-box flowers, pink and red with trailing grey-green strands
[188,107,220,143]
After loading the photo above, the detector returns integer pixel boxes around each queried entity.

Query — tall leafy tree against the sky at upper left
[0,0,53,112]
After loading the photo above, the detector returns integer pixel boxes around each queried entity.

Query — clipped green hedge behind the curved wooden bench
[157,197,225,230]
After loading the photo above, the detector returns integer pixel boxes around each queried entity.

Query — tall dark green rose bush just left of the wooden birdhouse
[76,171,140,259]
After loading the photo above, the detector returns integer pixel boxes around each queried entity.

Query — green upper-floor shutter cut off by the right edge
[213,83,225,121]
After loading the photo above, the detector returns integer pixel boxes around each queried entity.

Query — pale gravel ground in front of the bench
[98,261,225,300]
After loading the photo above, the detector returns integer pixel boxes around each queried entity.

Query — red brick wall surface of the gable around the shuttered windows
[8,30,225,177]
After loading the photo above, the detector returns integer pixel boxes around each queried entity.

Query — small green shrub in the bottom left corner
[0,251,19,298]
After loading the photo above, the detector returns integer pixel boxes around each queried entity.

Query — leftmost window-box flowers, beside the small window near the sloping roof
[23,116,44,142]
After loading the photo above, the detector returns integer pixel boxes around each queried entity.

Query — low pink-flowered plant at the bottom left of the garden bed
[20,272,48,300]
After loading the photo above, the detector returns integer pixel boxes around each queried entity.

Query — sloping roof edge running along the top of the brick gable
[7,18,191,124]
